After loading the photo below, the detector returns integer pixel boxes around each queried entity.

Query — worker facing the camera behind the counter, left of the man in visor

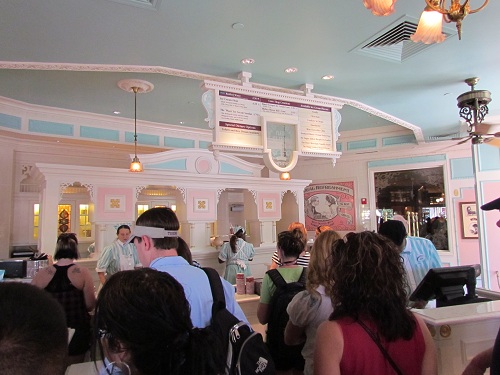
[96,224,141,286]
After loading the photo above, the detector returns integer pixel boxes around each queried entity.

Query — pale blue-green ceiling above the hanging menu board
[0,0,500,138]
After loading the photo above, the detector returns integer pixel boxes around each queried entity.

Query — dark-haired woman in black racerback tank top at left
[31,233,95,364]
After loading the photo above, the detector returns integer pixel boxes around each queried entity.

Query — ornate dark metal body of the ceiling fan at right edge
[457,77,491,132]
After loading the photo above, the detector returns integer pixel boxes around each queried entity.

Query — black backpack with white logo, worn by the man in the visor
[203,267,276,375]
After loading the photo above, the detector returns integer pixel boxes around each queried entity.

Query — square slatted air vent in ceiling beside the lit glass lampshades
[351,16,457,63]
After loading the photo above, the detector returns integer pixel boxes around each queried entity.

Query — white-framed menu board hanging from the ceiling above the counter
[202,81,342,172]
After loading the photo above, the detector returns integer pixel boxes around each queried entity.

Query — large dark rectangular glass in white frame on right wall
[373,166,449,250]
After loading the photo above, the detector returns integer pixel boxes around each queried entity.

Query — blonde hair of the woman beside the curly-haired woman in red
[306,230,341,295]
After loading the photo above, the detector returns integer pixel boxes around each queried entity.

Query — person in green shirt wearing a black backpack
[257,231,306,374]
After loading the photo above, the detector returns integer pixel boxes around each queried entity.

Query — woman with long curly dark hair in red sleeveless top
[314,231,437,375]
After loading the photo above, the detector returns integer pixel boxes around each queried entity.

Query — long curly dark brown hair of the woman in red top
[329,231,416,341]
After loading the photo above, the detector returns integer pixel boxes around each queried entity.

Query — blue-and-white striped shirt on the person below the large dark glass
[401,236,442,293]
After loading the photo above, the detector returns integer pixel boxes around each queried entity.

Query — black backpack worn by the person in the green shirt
[266,268,307,371]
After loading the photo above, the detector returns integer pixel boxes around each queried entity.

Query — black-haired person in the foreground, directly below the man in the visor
[94,268,225,375]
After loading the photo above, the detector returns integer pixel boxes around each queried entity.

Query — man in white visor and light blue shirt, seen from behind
[130,207,248,328]
